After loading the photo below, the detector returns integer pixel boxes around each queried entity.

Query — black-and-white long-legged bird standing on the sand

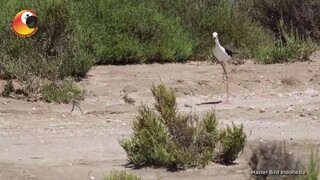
[212,32,237,103]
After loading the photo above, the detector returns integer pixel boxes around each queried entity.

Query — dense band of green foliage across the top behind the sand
[0,0,320,101]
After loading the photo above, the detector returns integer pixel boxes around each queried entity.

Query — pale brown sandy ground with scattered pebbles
[0,53,320,180]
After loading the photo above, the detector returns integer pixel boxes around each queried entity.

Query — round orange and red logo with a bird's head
[11,10,38,38]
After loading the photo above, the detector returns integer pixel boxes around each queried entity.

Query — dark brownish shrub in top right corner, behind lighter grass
[240,0,320,43]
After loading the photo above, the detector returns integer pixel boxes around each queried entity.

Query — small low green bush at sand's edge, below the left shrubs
[42,80,85,103]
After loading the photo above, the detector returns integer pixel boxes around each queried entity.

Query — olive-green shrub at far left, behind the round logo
[0,0,94,79]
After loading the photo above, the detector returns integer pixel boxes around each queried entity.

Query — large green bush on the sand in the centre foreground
[119,84,246,170]
